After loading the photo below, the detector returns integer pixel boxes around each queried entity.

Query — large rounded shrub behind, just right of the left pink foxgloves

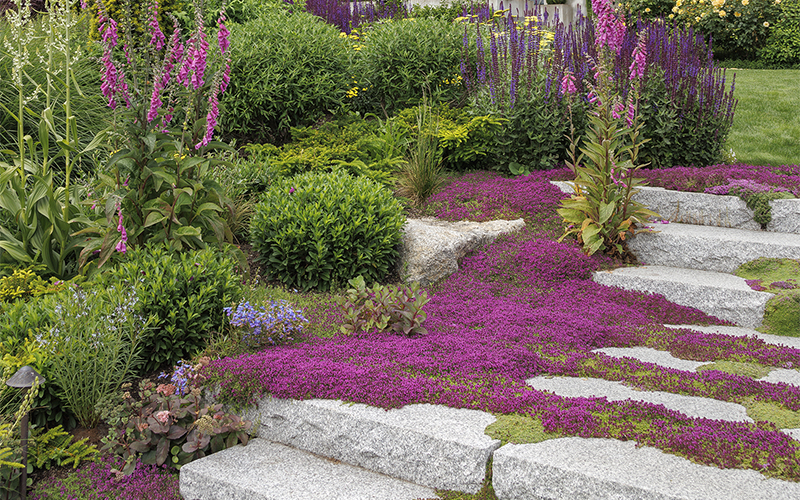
[220,9,351,143]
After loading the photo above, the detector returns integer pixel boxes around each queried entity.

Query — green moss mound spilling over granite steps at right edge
[736,257,800,337]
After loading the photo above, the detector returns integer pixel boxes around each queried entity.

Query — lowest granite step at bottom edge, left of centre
[180,439,437,500]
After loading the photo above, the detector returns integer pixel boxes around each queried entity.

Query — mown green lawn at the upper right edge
[726,69,800,165]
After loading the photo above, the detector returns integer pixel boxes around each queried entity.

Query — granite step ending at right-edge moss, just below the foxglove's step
[593,266,773,328]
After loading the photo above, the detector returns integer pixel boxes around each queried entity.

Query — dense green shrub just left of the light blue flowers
[105,245,243,373]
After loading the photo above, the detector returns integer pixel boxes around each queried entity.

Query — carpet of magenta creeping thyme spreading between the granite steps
[205,171,800,481]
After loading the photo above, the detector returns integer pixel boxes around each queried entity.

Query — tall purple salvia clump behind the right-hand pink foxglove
[462,7,735,173]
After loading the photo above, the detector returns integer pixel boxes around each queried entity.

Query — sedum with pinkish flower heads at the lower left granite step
[103,379,252,474]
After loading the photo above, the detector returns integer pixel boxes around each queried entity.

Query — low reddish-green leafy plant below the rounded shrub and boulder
[336,276,430,336]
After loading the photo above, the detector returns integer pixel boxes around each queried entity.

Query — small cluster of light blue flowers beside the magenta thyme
[224,300,308,347]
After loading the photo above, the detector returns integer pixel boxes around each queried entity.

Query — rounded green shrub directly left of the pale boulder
[250,171,405,291]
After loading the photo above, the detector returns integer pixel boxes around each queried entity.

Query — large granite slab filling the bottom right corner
[492,437,800,500]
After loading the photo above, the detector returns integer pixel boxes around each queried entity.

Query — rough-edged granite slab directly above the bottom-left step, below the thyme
[238,397,500,493]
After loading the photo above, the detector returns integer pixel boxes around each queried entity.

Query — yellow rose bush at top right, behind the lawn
[670,0,781,59]
